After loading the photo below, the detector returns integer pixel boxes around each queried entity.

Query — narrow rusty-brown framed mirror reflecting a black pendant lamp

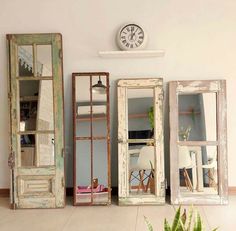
[72,72,111,205]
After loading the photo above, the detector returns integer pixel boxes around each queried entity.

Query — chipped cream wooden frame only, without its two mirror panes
[117,78,165,205]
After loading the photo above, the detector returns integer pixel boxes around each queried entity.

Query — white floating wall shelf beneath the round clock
[98,50,165,58]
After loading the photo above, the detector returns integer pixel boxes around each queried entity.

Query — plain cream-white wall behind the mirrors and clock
[0,0,236,188]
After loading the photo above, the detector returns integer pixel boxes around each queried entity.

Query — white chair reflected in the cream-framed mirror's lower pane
[129,146,154,191]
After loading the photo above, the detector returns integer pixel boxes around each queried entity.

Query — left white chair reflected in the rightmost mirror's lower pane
[179,146,195,191]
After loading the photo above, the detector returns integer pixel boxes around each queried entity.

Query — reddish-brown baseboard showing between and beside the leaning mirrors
[0,186,236,197]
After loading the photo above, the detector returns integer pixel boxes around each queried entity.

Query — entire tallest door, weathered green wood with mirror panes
[7,34,65,208]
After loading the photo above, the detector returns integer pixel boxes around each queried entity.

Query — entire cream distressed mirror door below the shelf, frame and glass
[117,78,165,205]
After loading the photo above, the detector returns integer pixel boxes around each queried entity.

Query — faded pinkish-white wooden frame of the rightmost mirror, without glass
[169,80,228,205]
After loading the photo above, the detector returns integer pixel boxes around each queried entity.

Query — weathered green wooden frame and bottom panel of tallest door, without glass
[7,34,65,208]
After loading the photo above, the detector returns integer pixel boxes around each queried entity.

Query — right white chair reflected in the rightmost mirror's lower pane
[202,152,217,188]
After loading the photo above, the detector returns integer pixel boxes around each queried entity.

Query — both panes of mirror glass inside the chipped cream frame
[127,89,155,196]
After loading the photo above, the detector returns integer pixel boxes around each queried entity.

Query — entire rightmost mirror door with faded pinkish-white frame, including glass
[169,80,228,204]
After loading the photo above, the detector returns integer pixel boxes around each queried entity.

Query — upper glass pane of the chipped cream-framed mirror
[128,89,154,139]
